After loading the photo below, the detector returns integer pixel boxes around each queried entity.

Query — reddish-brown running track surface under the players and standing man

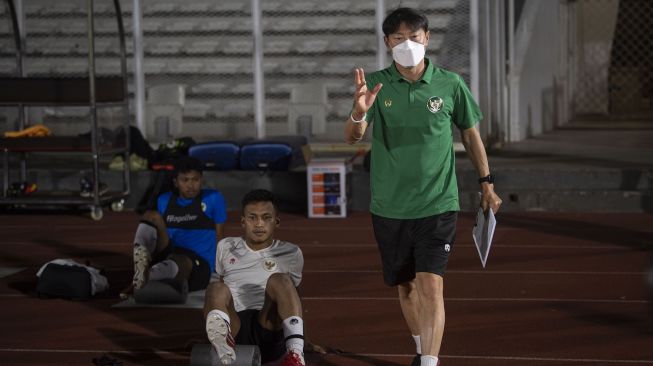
[0,212,653,366]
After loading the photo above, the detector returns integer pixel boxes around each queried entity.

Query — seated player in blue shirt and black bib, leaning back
[121,156,227,298]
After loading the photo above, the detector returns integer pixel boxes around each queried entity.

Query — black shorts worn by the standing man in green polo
[372,211,458,286]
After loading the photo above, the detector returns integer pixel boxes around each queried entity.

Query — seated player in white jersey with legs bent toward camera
[204,190,305,366]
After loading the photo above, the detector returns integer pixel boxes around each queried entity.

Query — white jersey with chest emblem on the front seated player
[215,237,304,311]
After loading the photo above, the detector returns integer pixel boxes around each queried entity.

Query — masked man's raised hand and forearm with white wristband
[345,68,383,144]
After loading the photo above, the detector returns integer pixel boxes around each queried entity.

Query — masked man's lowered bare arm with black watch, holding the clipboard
[461,127,502,213]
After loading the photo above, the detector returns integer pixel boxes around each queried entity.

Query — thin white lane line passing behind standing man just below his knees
[302,296,648,304]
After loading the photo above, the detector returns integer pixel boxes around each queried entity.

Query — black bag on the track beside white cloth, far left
[36,263,93,300]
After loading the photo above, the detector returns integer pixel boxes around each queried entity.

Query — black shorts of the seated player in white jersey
[235,309,286,363]
